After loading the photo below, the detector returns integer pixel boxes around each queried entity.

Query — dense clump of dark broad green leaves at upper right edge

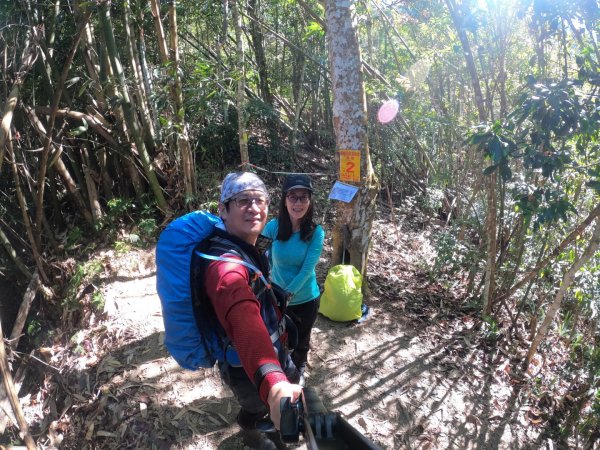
[468,71,600,239]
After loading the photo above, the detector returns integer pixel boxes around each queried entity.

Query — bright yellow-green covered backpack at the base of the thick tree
[319,264,363,322]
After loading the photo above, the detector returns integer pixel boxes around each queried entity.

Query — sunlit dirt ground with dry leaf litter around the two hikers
[3,206,580,449]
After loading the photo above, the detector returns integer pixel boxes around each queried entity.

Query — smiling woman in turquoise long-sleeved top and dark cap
[263,174,325,383]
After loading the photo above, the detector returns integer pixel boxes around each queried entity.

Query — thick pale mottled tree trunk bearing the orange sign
[325,0,378,282]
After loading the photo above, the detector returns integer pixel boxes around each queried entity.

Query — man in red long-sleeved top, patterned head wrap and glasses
[203,172,302,436]
